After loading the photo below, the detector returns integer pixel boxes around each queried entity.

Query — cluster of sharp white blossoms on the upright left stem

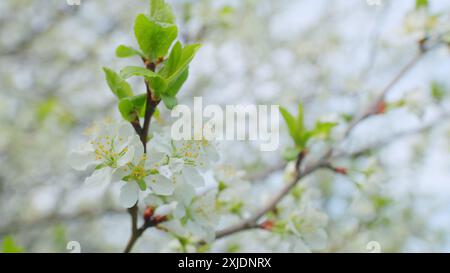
[71,122,218,241]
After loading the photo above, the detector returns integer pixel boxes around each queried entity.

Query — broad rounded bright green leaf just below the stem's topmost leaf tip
[134,14,178,62]
